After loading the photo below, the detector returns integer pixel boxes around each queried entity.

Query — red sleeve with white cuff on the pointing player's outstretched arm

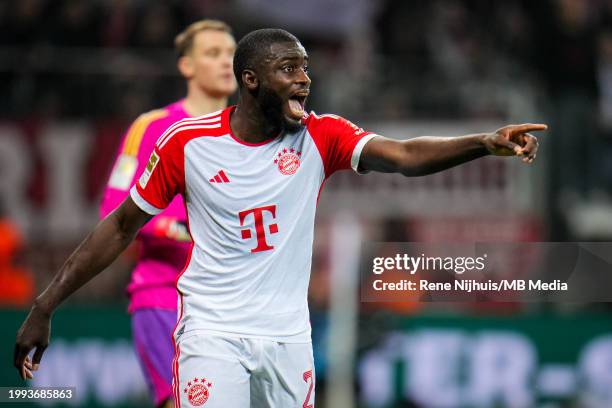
[307,114,377,177]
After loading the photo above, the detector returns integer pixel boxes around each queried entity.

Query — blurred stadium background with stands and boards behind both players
[0,0,612,408]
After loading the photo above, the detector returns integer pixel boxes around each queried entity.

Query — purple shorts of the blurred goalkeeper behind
[132,309,177,407]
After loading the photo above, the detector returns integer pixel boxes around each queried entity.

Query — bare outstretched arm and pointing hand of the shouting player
[359,123,547,176]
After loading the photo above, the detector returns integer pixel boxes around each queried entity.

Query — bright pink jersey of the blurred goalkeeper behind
[100,100,191,312]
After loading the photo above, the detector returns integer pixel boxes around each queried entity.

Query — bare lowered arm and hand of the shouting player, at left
[14,197,151,379]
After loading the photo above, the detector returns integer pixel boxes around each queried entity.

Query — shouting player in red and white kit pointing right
[14,29,546,408]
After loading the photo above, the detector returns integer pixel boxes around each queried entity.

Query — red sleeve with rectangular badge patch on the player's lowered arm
[130,139,185,215]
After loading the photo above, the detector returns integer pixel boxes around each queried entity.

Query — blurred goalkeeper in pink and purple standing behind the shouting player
[100,20,236,407]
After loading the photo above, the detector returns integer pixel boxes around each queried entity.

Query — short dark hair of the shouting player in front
[234,28,300,86]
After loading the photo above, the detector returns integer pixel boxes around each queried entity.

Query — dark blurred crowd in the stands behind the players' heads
[0,0,612,121]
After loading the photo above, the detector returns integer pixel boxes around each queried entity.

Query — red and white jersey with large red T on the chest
[131,107,375,343]
